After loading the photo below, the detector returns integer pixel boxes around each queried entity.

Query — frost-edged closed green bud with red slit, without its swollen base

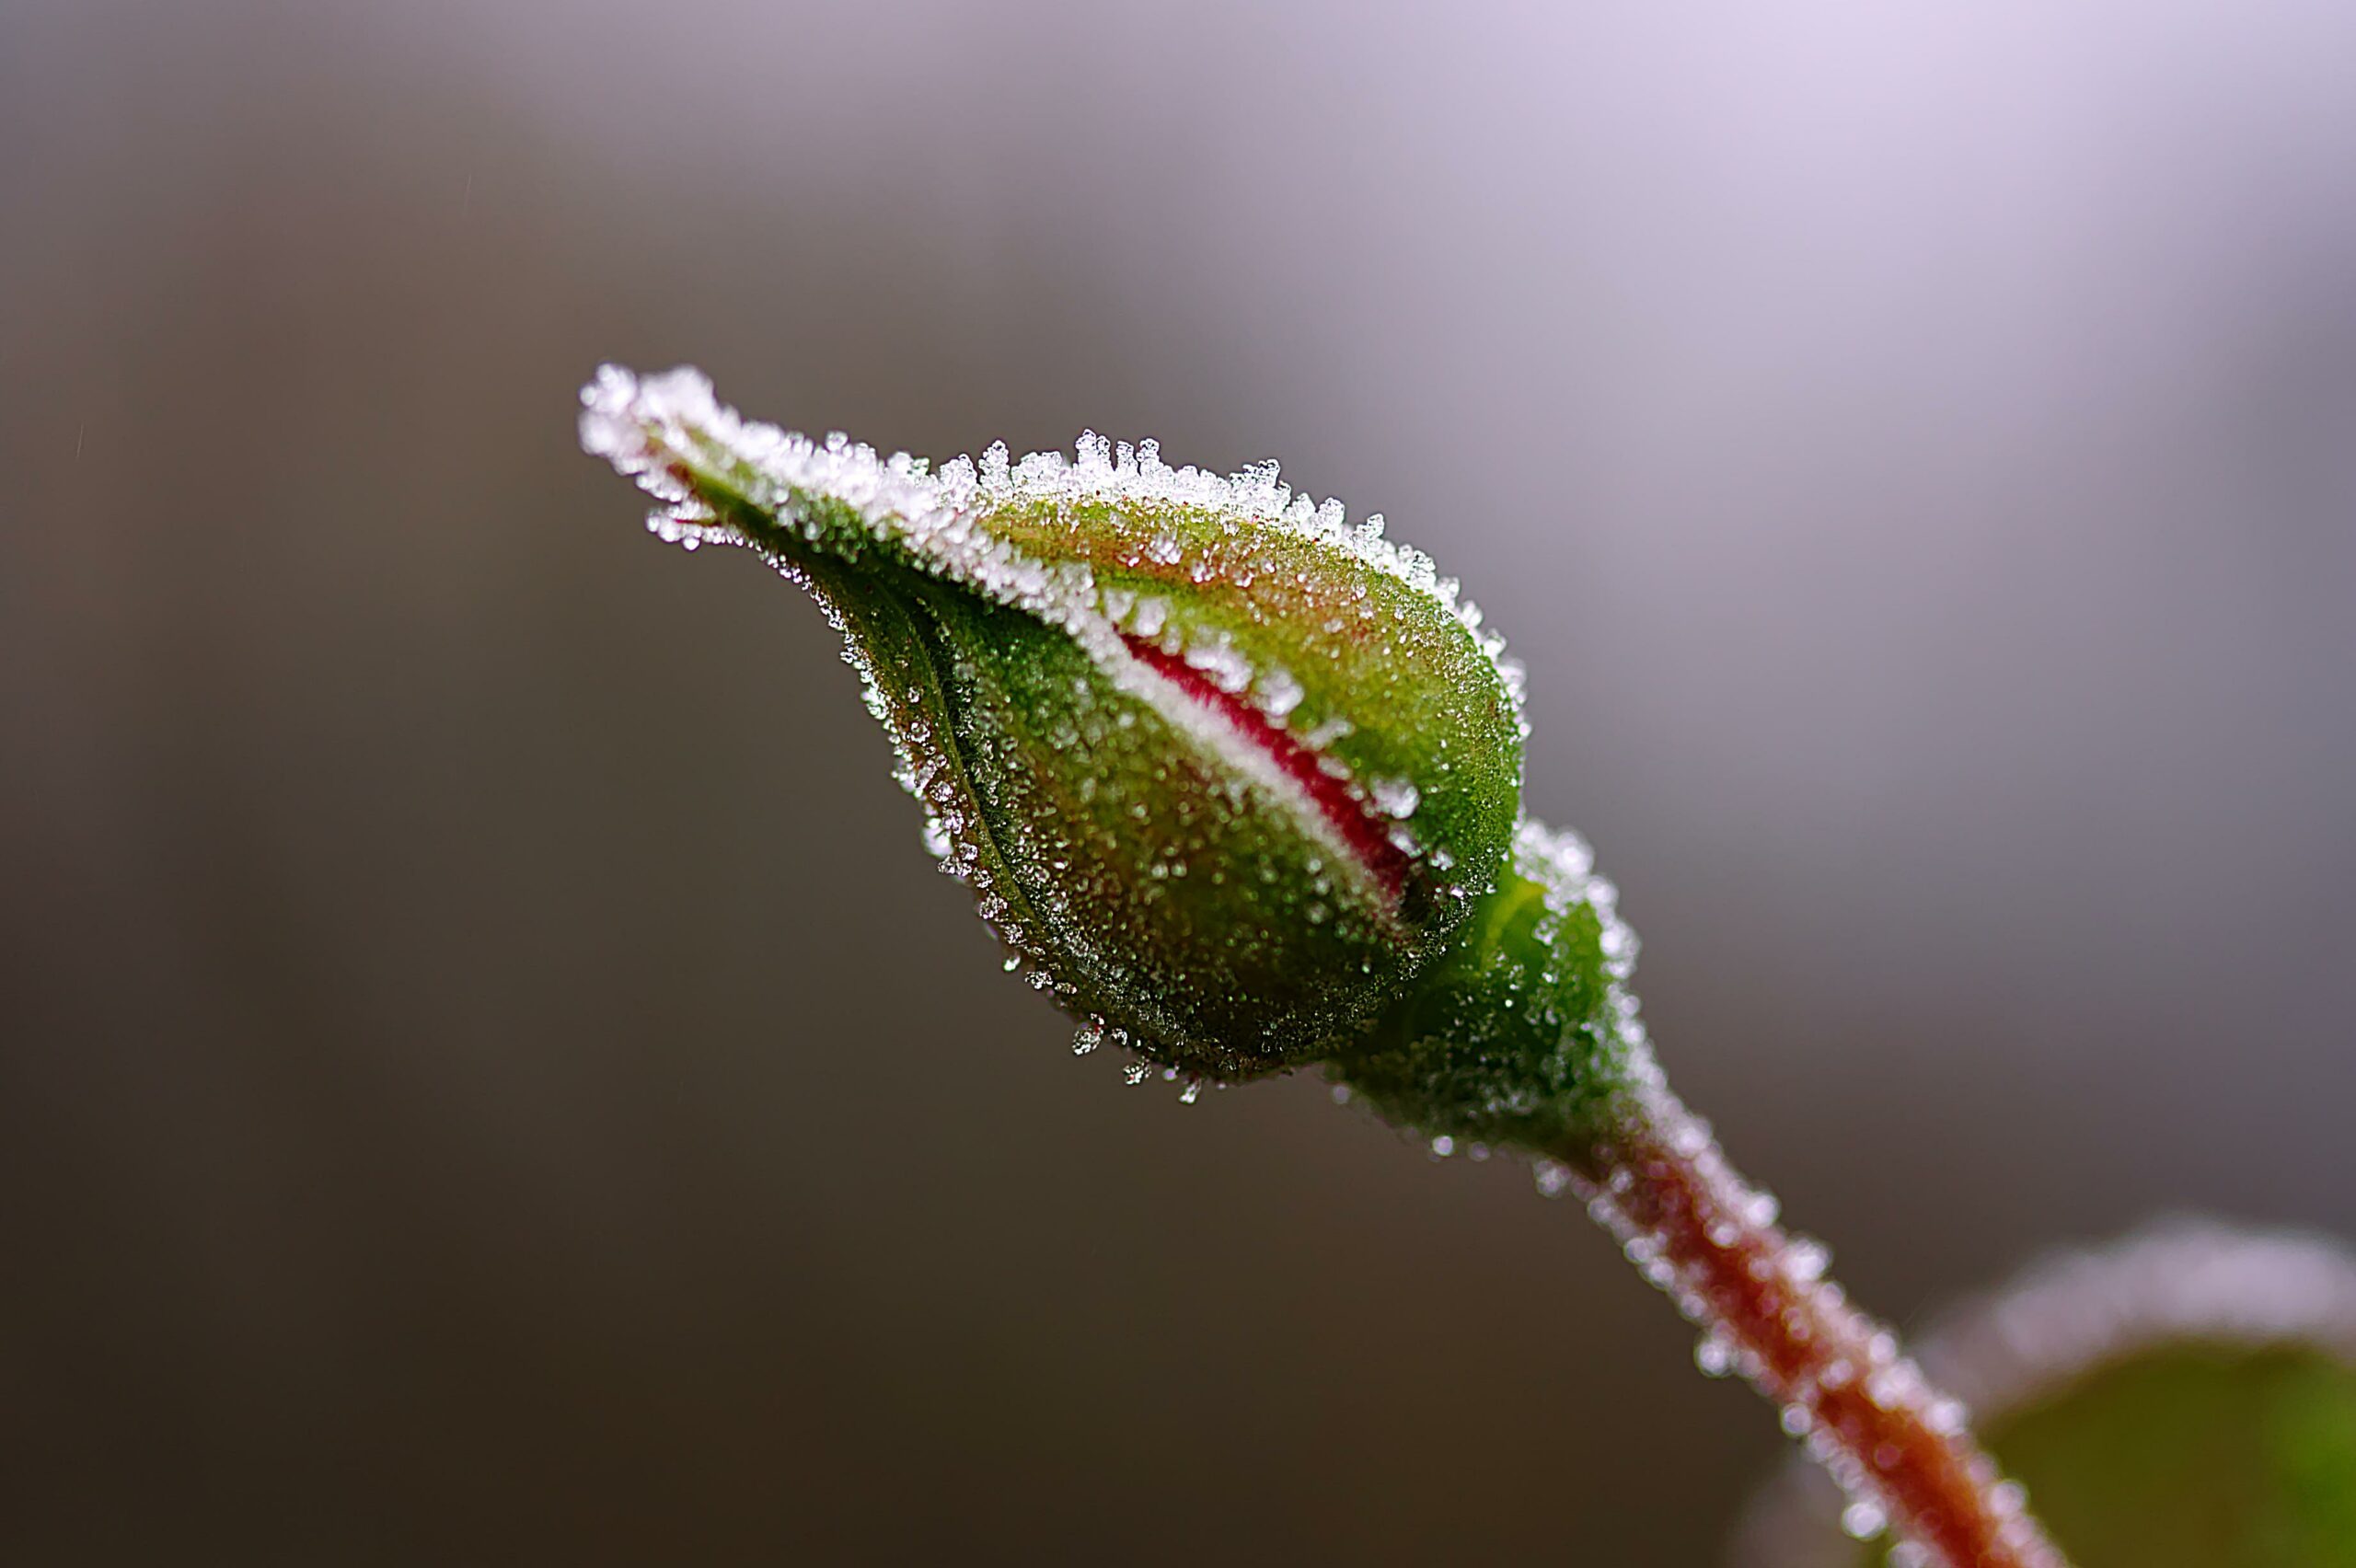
[582,367,1522,1078]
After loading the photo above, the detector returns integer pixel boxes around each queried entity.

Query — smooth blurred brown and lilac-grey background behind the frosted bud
[0,0,2356,1565]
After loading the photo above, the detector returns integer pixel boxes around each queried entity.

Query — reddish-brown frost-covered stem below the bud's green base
[1572,1088,2066,1568]
